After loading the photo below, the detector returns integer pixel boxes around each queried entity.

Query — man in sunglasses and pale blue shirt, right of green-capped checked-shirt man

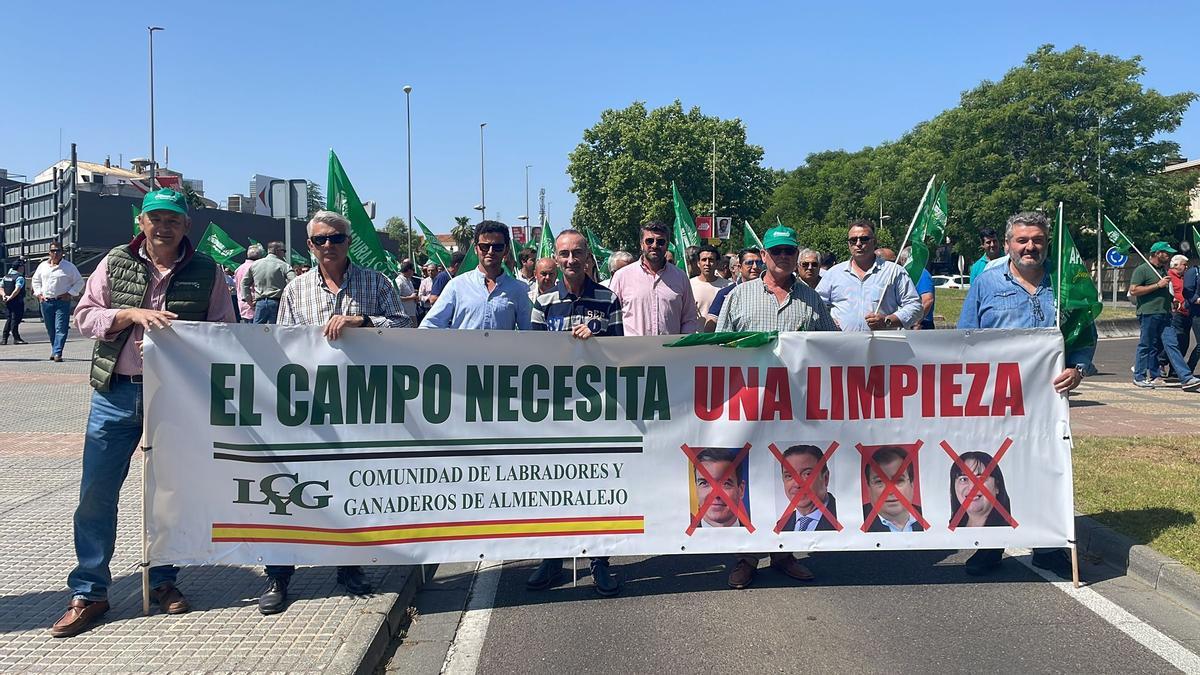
[817,220,920,331]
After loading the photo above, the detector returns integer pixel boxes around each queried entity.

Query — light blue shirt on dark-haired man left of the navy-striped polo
[421,269,533,330]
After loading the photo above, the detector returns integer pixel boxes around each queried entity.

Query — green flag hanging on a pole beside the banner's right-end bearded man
[1048,202,1104,353]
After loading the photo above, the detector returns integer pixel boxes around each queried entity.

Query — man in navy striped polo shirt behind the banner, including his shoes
[526,229,625,597]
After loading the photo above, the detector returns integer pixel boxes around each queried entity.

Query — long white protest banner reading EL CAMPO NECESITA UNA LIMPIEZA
[145,322,1074,565]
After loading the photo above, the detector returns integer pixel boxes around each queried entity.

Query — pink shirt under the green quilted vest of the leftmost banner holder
[74,235,236,375]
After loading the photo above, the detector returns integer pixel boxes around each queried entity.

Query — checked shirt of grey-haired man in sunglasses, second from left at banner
[278,263,413,328]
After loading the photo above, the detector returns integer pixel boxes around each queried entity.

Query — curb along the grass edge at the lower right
[1075,515,1200,614]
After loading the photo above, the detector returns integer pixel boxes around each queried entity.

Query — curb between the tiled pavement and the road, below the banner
[328,565,437,675]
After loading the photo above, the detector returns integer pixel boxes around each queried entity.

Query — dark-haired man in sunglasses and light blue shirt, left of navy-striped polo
[421,220,532,330]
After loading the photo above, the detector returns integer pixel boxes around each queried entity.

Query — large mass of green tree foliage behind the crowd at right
[761,44,1196,259]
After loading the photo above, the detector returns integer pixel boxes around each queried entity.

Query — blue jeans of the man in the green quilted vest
[67,377,179,601]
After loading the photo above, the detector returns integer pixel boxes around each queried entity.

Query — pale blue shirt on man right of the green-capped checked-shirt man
[817,256,920,331]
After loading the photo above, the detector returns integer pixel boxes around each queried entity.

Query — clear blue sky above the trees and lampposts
[0,1,1200,232]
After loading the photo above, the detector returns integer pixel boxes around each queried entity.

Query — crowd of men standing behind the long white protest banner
[35,190,1104,637]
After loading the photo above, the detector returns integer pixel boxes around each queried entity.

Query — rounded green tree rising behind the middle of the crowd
[566,101,776,251]
